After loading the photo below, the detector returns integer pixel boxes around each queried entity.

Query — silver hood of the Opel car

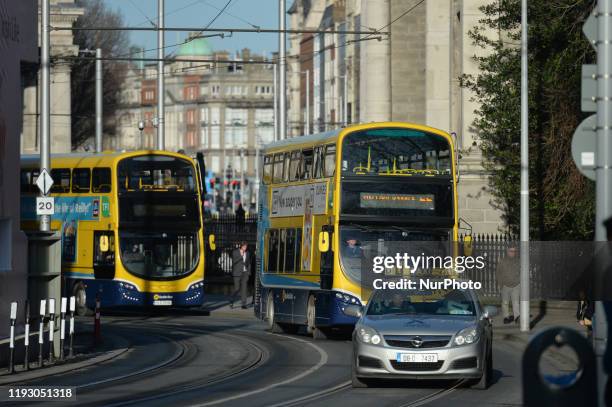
[362,315,477,336]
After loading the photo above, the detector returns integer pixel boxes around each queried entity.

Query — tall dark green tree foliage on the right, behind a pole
[461,0,595,240]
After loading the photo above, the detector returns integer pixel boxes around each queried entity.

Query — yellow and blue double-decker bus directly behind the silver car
[256,122,458,337]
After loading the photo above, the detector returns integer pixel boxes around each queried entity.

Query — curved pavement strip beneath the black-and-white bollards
[0,324,129,386]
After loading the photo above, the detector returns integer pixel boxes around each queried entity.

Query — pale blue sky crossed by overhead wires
[104,0,291,57]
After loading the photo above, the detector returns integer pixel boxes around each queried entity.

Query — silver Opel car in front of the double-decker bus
[345,290,497,389]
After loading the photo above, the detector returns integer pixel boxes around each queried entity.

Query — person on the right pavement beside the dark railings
[496,245,521,324]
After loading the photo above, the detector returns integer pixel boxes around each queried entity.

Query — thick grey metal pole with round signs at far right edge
[593,0,612,406]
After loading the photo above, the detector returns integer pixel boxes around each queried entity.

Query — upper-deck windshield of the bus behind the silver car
[341,128,451,176]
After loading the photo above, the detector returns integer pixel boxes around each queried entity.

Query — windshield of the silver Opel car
[366,290,476,316]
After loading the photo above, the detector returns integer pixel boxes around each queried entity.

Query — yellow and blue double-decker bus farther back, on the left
[21,151,204,314]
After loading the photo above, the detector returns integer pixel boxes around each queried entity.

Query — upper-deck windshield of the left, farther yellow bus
[117,155,196,192]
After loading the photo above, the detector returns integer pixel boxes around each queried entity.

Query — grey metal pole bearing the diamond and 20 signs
[40,0,51,232]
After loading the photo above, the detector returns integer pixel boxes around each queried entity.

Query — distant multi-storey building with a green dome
[114,38,274,212]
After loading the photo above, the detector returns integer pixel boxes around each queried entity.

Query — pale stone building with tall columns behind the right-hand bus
[288,0,504,233]
